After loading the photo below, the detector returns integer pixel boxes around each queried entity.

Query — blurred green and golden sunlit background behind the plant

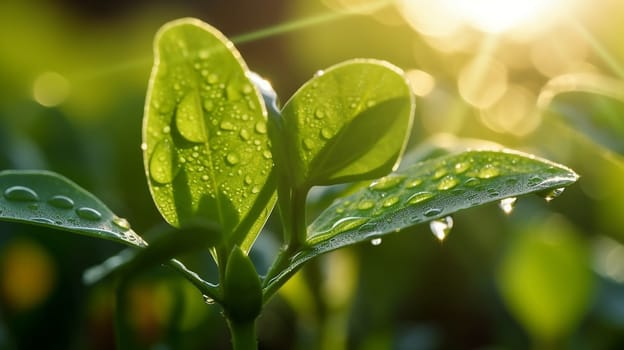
[0,0,624,349]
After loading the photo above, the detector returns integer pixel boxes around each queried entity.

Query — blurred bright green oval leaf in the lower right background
[497,218,592,345]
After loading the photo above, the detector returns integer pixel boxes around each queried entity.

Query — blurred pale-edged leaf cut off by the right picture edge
[538,74,624,154]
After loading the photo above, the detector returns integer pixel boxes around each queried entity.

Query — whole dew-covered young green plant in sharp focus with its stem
[0,19,577,349]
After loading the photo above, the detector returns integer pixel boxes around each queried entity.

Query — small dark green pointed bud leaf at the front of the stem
[223,246,262,323]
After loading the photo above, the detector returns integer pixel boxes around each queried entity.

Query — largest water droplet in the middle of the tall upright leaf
[175,92,206,142]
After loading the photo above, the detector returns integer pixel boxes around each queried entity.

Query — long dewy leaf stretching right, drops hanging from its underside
[265,150,578,294]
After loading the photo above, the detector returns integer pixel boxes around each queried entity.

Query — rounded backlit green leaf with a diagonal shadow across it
[282,60,414,188]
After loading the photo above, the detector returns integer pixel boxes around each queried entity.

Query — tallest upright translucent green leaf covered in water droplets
[142,18,275,250]
